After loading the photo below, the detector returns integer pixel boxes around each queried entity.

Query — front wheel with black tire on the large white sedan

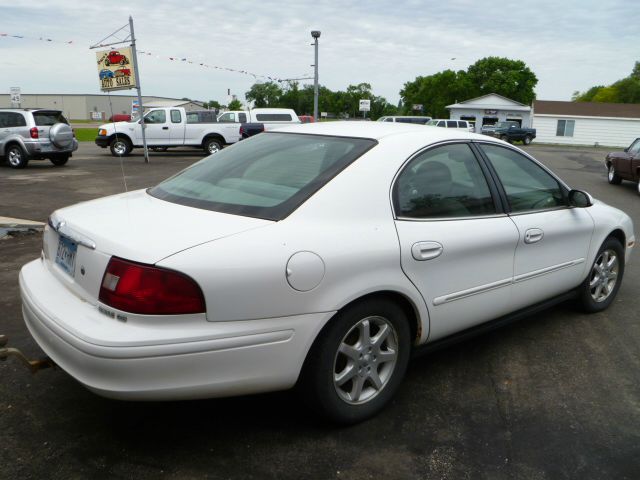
[578,237,624,313]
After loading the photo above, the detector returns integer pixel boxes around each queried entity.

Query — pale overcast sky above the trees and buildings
[0,0,640,104]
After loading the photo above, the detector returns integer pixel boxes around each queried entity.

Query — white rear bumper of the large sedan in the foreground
[20,260,333,400]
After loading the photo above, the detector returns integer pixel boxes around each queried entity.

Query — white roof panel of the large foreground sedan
[274,121,488,142]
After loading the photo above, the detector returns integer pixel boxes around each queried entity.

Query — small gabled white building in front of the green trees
[446,93,531,133]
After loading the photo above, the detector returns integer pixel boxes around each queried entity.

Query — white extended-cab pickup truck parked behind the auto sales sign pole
[96,107,240,157]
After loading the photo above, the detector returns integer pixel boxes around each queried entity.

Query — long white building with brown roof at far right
[533,100,640,147]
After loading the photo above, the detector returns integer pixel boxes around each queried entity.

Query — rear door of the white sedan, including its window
[392,143,518,340]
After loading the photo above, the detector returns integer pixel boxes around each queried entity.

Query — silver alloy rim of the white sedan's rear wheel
[333,316,398,405]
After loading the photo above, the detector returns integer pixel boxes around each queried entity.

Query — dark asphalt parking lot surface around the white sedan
[0,144,640,480]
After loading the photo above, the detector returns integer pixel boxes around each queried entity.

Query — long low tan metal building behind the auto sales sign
[0,93,203,120]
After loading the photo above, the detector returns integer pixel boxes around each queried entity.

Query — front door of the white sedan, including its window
[480,144,594,310]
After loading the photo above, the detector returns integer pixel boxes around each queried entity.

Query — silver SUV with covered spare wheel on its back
[0,108,78,168]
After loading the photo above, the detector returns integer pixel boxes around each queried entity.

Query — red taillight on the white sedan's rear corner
[100,257,205,315]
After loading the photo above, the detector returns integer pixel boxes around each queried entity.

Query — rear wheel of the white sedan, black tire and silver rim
[298,299,411,424]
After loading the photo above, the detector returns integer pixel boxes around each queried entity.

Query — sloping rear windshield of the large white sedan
[148,132,377,220]
